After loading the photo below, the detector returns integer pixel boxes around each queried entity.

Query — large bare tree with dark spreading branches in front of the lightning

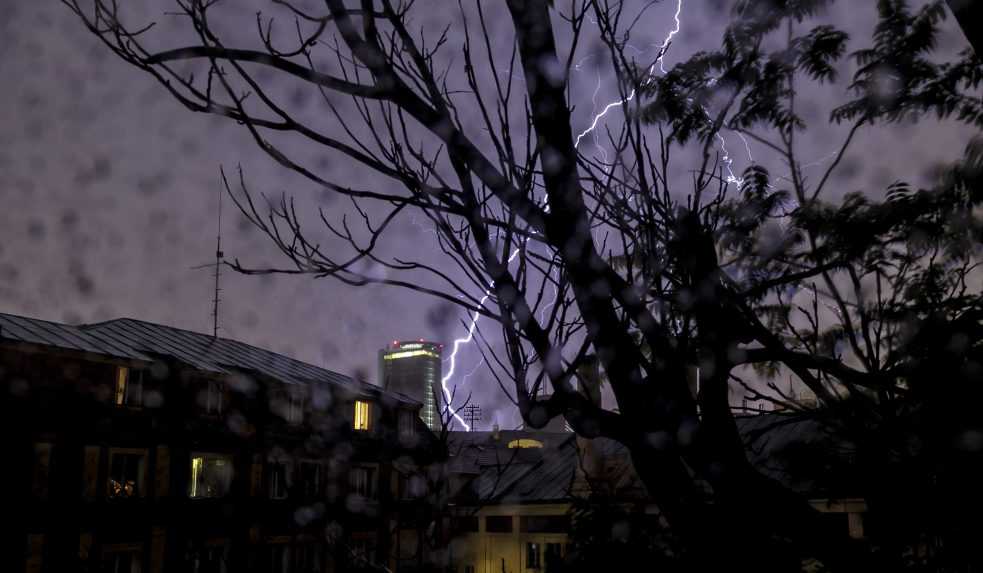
[63,0,981,570]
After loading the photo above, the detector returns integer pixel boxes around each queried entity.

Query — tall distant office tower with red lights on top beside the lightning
[379,339,444,431]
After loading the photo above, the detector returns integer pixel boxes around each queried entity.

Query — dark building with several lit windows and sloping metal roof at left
[0,314,431,573]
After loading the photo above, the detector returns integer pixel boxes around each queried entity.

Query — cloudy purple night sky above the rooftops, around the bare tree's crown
[0,0,967,426]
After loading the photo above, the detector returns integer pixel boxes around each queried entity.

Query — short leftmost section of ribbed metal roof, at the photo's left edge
[0,313,152,361]
